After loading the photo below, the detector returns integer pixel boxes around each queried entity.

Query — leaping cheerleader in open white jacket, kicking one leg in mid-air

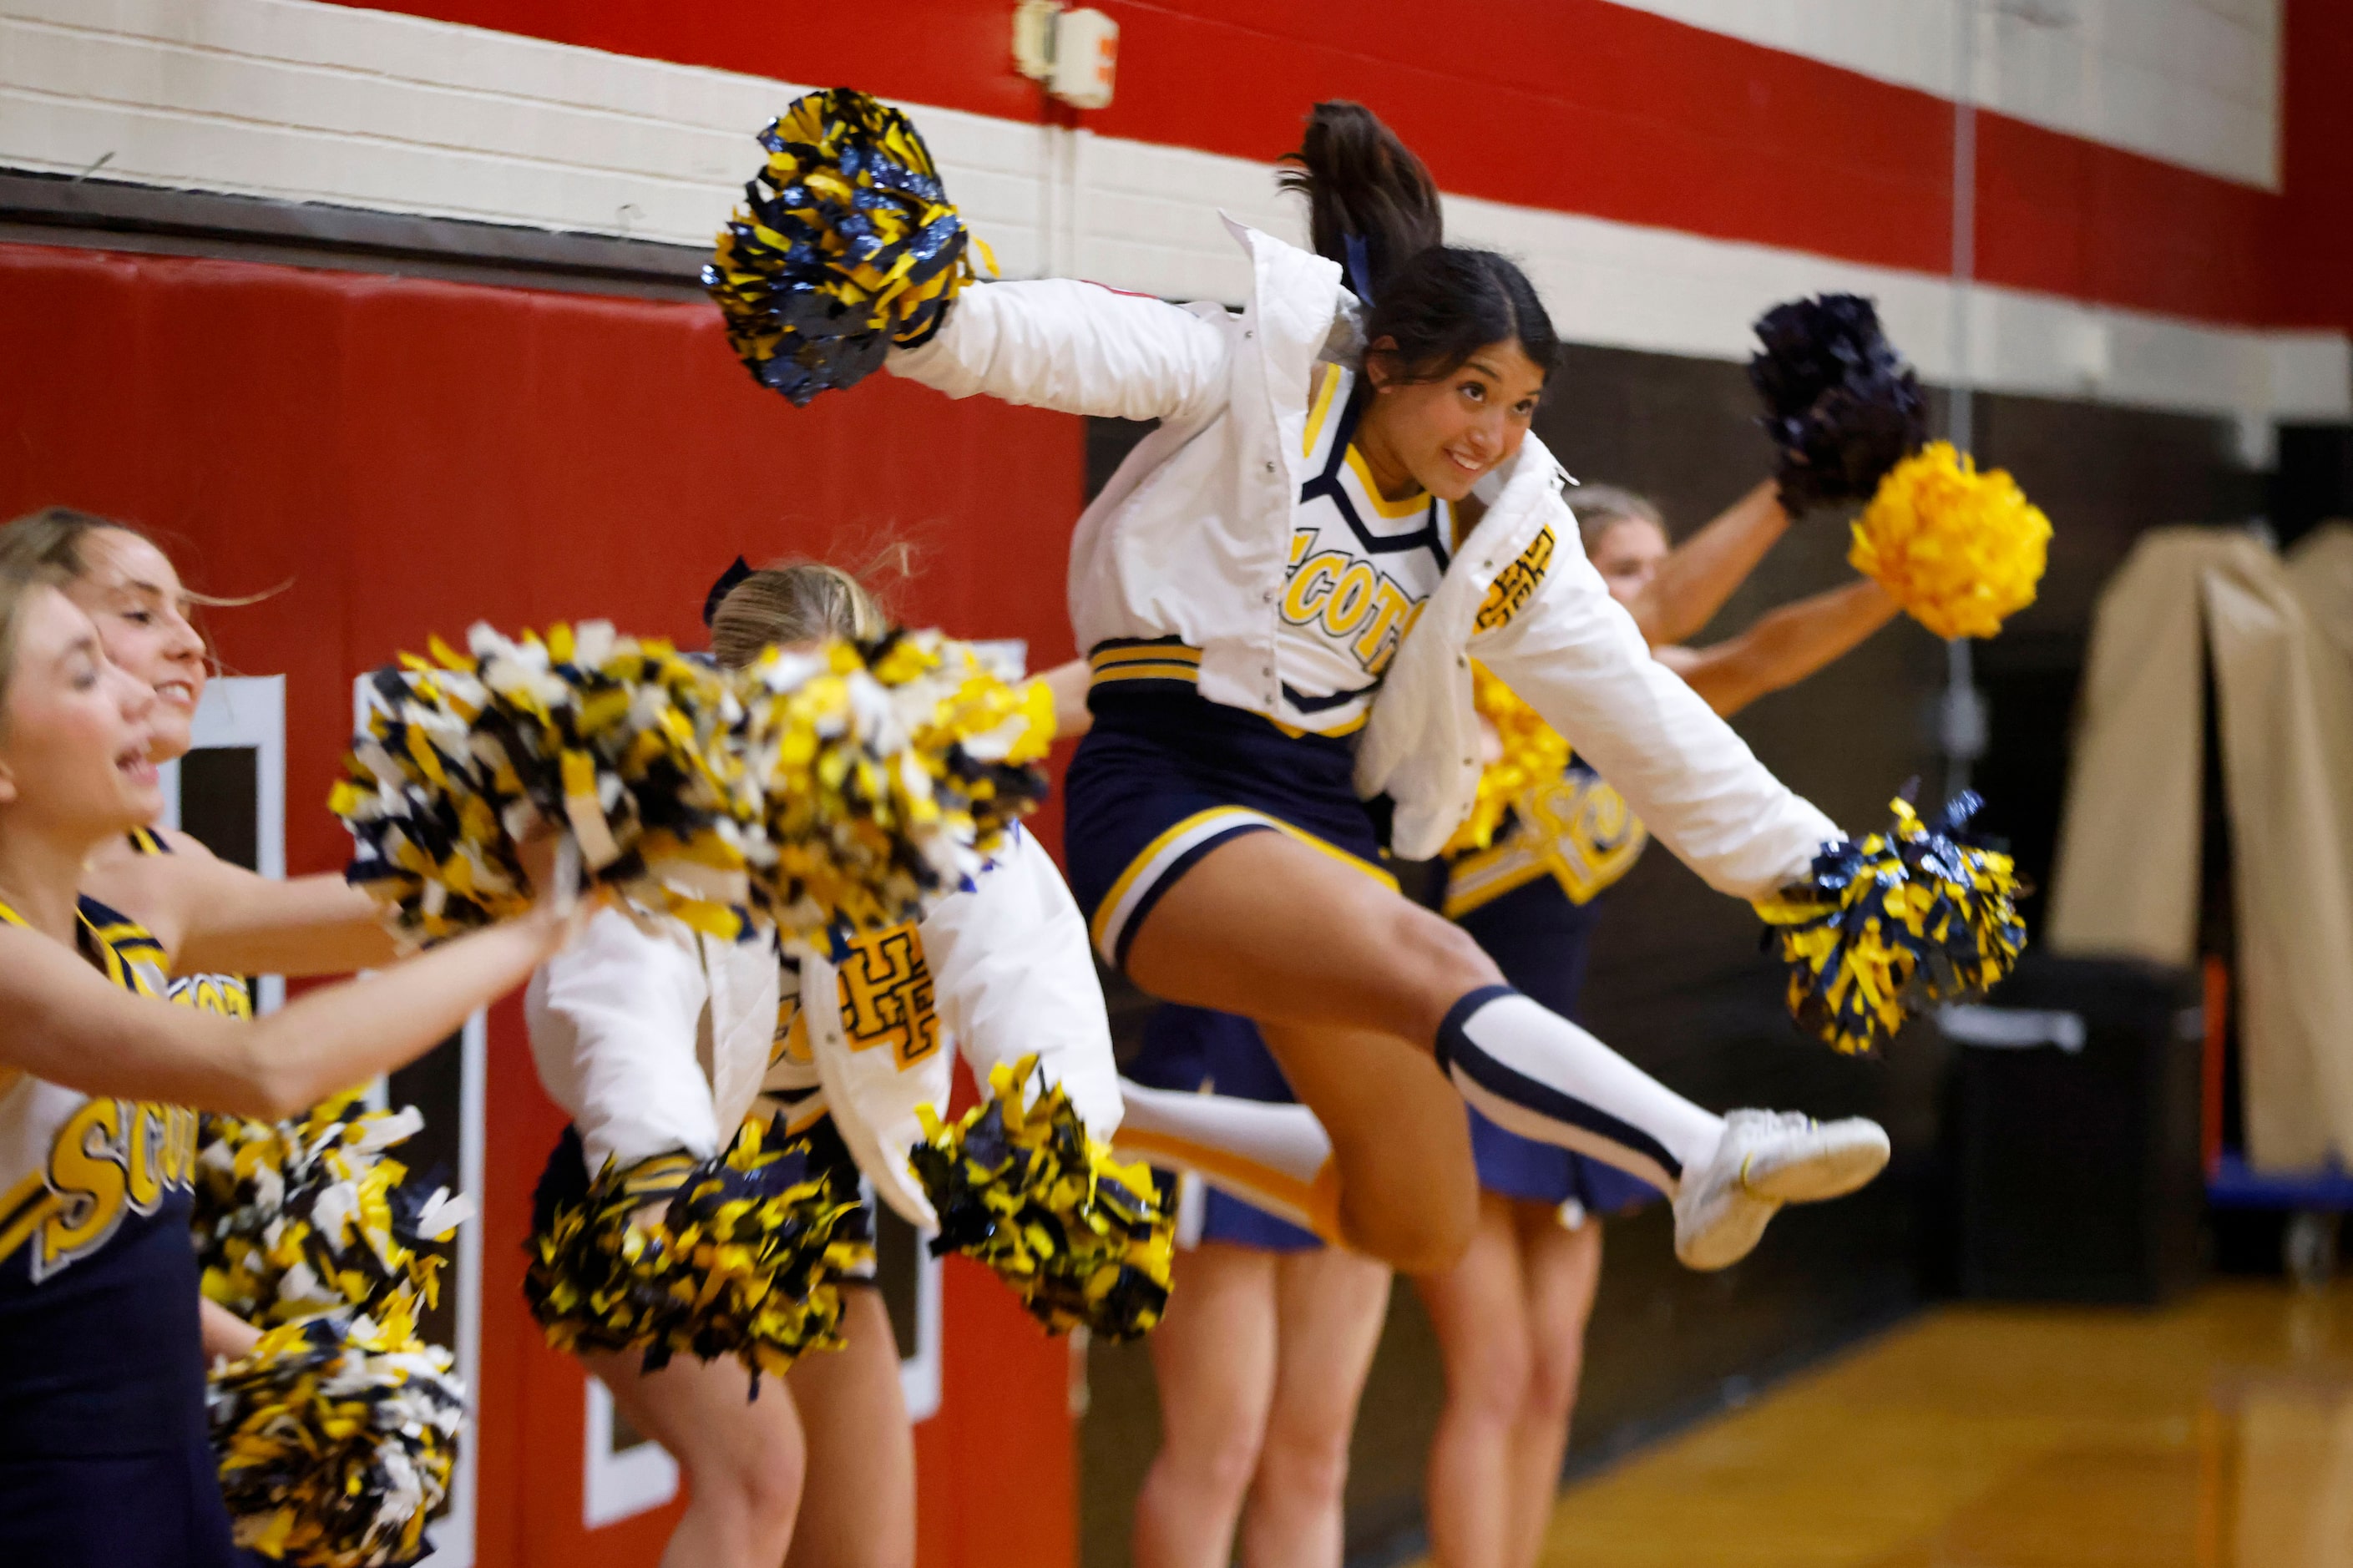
[889,104,1887,1272]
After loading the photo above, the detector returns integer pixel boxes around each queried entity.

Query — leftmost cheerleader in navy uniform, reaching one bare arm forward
[0,562,576,1565]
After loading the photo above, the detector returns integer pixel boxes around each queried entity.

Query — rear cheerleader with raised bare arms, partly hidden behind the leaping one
[1411,483,1896,1568]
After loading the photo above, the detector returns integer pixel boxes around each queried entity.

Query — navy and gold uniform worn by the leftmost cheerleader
[0,897,245,1568]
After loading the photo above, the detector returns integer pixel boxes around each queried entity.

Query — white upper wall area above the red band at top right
[1612,0,2282,190]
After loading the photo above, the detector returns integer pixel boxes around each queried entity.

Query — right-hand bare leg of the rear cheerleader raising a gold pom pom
[1506,1203,1602,1568]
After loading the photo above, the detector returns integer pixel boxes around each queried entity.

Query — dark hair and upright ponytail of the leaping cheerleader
[1280,99,1560,382]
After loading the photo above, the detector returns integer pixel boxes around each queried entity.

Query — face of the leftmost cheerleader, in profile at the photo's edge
[0,586,162,845]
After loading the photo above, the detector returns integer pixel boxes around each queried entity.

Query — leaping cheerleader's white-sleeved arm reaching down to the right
[1470,494,1842,899]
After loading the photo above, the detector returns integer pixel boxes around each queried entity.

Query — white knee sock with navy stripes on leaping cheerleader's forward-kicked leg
[1438,987,1725,1194]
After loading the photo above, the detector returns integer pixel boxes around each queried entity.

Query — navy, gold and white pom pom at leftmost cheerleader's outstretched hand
[327,621,760,939]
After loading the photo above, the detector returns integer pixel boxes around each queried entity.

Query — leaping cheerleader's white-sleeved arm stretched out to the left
[889,278,1235,419]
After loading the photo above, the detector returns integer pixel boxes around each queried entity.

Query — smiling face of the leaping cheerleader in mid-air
[1355,336,1544,502]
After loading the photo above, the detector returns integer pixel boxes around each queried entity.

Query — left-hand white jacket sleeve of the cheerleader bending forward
[523,908,731,1172]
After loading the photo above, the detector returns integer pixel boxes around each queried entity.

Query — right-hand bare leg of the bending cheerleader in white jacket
[786,1286,915,1568]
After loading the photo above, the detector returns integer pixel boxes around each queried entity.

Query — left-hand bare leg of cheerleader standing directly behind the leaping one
[1134,1241,1275,1568]
